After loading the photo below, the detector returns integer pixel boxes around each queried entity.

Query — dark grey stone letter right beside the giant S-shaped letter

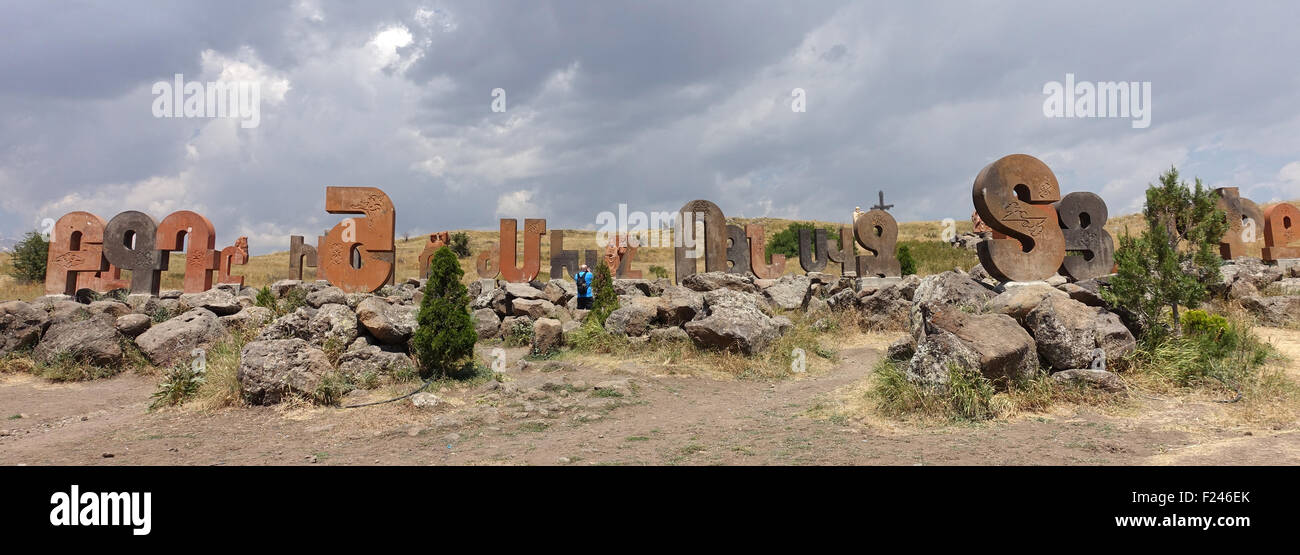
[1056,192,1115,281]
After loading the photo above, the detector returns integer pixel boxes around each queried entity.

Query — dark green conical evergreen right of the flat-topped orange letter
[411,247,478,377]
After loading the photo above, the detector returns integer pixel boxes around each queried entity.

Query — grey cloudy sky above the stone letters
[0,0,1300,253]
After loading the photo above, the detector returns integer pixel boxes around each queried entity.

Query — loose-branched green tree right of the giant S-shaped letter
[1102,166,1229,343]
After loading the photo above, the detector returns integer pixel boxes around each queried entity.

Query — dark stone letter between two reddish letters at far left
[104,211,168,296]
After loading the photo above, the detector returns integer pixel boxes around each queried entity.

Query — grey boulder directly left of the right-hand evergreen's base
[1024,296,1138,370]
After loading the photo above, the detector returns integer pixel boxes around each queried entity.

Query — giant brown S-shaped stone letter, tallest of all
[971,155,1065,281]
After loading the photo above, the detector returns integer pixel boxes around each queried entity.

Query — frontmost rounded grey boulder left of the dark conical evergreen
[235,338,334,404]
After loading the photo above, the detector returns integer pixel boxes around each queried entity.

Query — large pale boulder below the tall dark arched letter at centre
[685,288,781,355]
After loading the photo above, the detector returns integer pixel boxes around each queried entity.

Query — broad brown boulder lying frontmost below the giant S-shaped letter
[909,307,1039,383]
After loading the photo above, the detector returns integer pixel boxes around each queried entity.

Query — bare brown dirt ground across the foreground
[0,330,1300,465]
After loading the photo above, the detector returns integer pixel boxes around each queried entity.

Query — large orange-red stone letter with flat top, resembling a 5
[317,187,395,292]
